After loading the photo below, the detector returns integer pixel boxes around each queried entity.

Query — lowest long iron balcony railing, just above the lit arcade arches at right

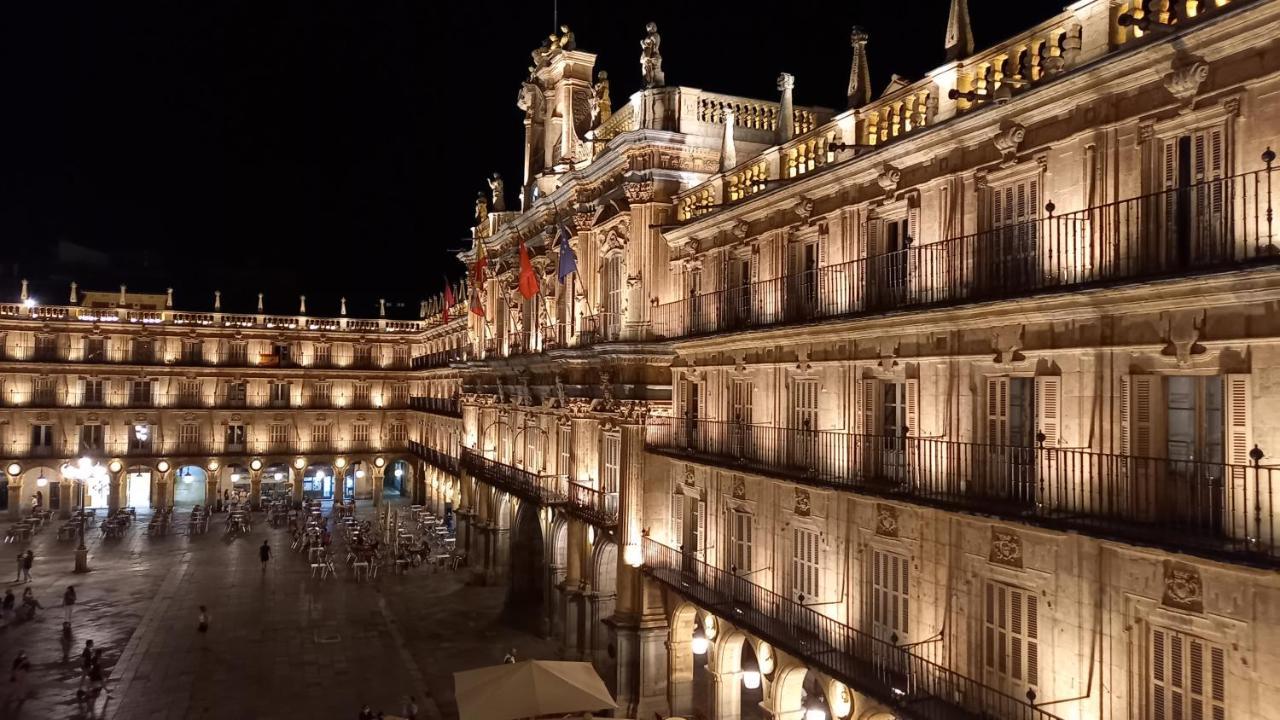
[643,538,1057,720]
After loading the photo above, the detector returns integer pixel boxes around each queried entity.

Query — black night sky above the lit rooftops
[0,0,1065,316]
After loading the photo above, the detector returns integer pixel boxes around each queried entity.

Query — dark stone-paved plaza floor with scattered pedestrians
[0,502,554,720]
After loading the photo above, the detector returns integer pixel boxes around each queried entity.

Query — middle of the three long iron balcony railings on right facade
[646,419,1280,564]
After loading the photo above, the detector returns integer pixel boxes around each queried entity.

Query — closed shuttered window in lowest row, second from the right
[982,580,1039,696]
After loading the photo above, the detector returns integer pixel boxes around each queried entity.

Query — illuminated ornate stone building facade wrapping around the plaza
[0,0,1280,720]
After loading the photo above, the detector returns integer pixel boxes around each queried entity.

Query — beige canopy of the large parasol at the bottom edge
[453,660,618,720]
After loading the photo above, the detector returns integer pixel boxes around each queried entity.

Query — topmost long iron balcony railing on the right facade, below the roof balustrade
[653,161,1280,338]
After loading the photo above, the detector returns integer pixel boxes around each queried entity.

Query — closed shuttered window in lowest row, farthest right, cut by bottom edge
[1147,628,1226,720]
